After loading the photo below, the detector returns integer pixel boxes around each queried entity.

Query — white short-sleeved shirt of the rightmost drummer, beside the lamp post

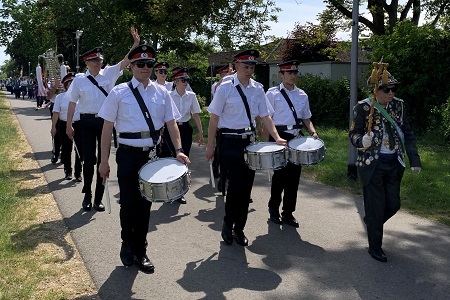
[266,83,311,126]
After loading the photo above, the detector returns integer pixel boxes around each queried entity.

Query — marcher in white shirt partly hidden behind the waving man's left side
[51,73,83,182]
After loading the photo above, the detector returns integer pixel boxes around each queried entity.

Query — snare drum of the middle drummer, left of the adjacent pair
[244,142,287,170]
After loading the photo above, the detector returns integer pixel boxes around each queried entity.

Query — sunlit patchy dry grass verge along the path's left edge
[0,94,96,300]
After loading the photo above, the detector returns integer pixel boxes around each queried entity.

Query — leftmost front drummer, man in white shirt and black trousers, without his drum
[99,45,190,273]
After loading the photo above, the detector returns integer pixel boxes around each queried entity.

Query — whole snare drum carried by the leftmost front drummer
[139,158,191,202]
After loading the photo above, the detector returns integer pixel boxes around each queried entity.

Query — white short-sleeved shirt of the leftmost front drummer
[98,77,181,147]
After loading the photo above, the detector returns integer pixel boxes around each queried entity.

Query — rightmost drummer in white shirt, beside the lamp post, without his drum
[266,61,319,227]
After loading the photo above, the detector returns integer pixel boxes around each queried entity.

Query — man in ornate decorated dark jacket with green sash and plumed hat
[349,66,421,262]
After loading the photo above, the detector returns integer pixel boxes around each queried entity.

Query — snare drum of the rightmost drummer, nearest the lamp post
[288,136,326,166]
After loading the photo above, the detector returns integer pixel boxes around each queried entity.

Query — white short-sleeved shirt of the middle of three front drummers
[208,74,272,129]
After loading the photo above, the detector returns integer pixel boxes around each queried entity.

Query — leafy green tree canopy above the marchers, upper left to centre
[0,0,278,72]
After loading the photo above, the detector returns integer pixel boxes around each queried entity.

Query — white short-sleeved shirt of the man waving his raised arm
[66,62,122,114]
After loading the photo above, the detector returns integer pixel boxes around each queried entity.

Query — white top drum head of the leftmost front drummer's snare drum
[139,158,187,183]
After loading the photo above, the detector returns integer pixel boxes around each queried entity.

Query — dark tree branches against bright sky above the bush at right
[324,0,450,35]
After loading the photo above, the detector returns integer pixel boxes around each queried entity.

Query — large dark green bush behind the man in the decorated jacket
[368,21,450,131]
